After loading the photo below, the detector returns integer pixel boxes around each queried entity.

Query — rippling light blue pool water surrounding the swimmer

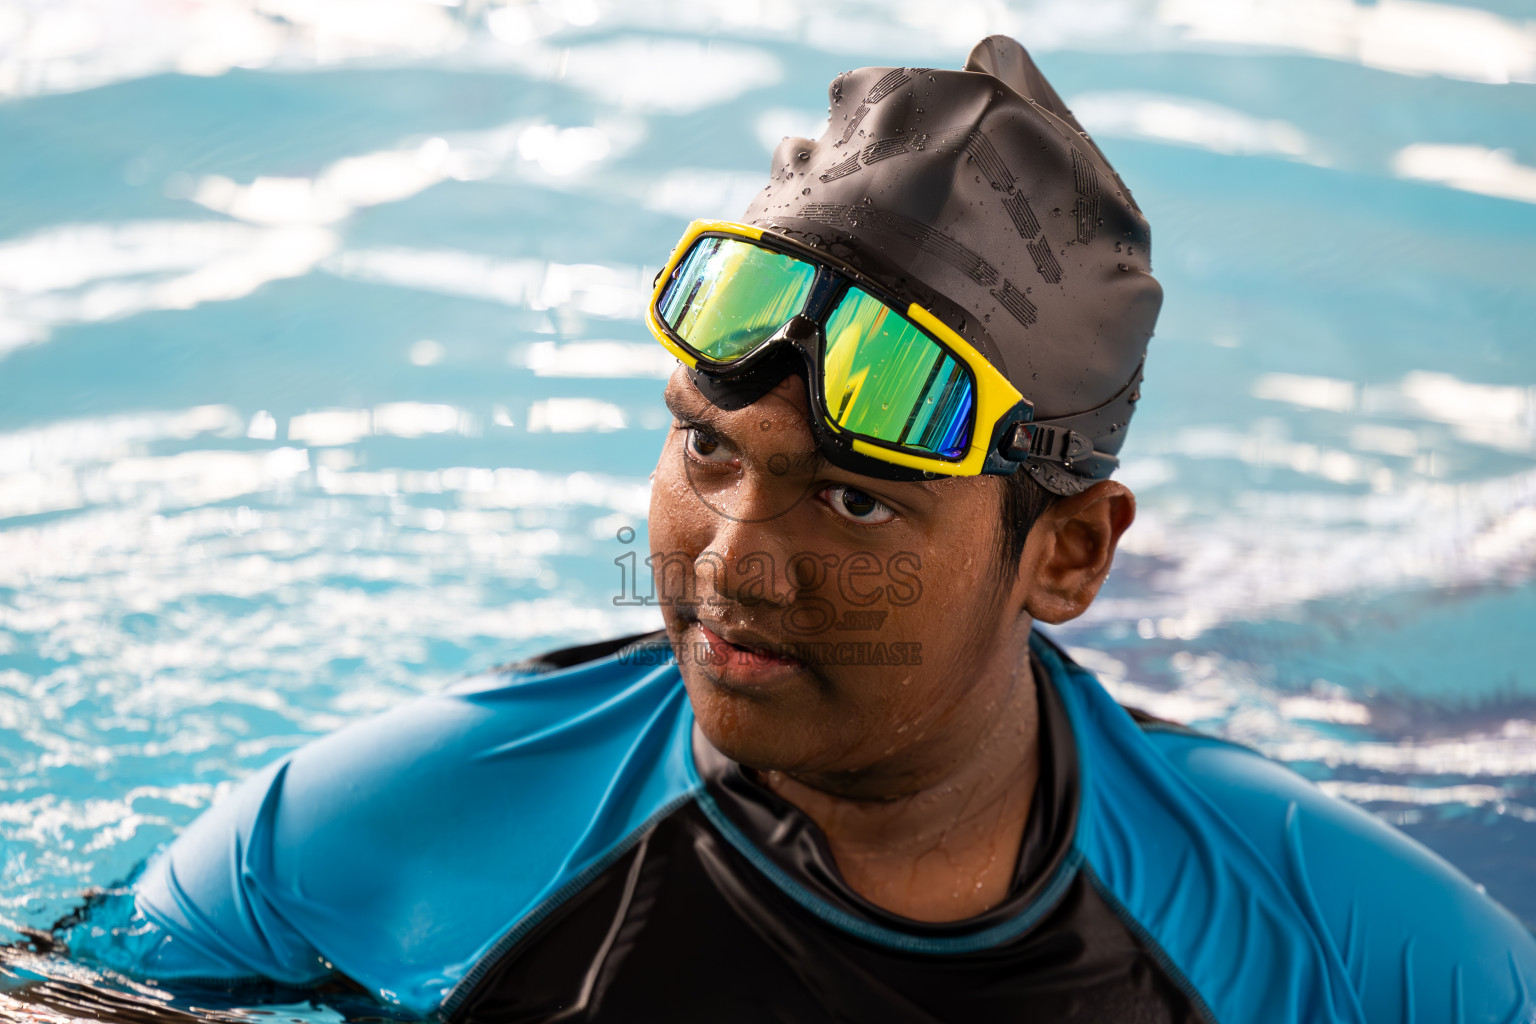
[0,0,1536,1019]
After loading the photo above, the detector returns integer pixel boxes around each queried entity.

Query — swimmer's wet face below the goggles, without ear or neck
[650,368,1029,775]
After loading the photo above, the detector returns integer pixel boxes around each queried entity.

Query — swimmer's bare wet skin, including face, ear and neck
[650,370,1135,921]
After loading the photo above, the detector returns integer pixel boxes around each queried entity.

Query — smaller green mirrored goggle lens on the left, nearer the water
[659,238,816,362]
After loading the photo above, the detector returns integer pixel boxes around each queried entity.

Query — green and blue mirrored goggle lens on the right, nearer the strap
[822,287,975,459]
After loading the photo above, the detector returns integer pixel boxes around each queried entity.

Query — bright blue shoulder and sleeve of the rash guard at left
[135,634,691,1012]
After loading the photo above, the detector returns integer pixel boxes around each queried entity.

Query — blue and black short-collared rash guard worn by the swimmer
[111,634,1536,1024]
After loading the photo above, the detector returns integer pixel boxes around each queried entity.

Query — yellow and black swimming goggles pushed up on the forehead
[647,221,1107,481]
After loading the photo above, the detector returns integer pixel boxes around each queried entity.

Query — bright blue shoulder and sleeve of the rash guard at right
[1037,642,1536,1024]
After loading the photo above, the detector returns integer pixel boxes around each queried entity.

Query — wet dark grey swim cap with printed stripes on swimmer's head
[743,35,1163,494]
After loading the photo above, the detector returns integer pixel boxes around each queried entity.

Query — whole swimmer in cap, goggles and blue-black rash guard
[77,37,1536,1024]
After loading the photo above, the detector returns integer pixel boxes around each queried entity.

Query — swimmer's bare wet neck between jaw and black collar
[760,648,1040,921]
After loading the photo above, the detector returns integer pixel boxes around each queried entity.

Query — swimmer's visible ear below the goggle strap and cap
[1018,481,1137,623]
